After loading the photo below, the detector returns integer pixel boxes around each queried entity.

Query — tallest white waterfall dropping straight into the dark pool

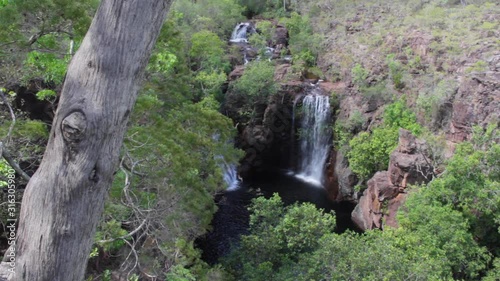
[297,92,331,186]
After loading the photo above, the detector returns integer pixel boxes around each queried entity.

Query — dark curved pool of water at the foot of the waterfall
[196,171,356,264]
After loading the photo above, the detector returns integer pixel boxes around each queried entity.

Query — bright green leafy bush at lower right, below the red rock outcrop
[397,190,489,280]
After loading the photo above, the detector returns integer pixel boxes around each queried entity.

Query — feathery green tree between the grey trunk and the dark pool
[94,91,241,280]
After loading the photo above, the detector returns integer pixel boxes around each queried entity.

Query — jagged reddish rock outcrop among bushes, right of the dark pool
[352,129,433,230]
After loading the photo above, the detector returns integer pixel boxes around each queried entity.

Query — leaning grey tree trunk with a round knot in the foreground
[13,0,172,281]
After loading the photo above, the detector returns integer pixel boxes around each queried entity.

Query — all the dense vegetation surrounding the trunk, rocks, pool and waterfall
[0,0,500,281]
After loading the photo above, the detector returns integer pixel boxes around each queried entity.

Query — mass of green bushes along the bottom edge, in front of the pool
[223,194,476,281]
